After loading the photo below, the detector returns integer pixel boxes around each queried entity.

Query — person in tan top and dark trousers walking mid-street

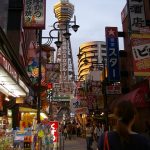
[85,123,93,150]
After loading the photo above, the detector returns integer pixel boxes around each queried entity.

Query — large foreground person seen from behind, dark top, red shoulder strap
[98,101,150,150]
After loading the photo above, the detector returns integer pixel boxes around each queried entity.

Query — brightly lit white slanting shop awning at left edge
[0,52,29,97]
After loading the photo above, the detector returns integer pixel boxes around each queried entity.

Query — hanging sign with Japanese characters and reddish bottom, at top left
[23,0,46,29]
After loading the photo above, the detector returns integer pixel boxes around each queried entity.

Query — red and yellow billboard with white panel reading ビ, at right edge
[131,34,150,76]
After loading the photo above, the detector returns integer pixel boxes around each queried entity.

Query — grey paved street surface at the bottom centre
[64,137,86,150]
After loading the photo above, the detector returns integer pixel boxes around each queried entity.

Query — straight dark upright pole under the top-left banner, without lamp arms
[37,30,42,123]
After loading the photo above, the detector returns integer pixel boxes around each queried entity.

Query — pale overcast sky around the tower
[43,0,126,73]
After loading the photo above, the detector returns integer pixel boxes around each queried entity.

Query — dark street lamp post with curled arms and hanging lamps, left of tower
[37,16,79,120]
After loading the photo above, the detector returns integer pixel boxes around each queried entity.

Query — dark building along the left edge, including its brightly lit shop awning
[0,0,37,129]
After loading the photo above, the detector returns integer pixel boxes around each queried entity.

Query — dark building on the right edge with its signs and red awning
[118,0,150,132]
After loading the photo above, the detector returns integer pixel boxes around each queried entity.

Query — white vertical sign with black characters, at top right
[127,0,146,31]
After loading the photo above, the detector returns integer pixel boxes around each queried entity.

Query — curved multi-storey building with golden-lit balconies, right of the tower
[78,41,106,80]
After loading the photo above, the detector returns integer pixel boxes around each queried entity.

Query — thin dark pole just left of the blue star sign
[102,57,108,129]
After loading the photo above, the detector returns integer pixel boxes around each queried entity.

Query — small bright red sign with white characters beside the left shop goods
[50,121,59,142]
